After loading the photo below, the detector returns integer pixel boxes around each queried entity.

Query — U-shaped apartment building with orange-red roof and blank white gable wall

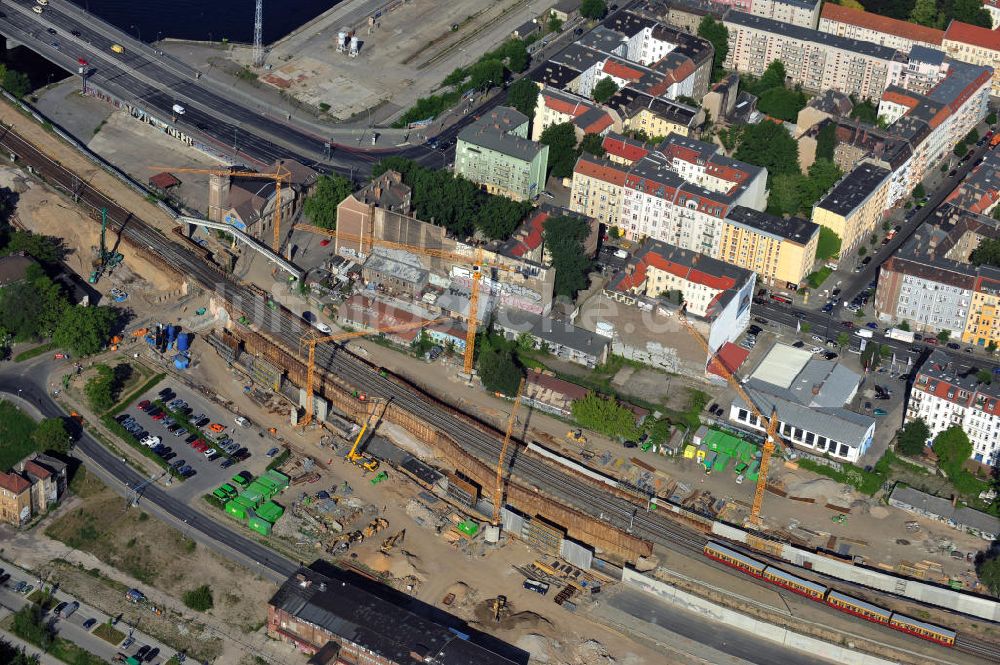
[604,239,757,352]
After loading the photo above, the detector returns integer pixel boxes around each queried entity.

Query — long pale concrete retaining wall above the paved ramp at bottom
[623,568,894,665]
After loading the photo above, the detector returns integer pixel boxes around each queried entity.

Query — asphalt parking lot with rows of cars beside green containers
[119,383,273,498]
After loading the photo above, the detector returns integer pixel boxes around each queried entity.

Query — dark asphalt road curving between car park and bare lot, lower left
[0,361,297,582]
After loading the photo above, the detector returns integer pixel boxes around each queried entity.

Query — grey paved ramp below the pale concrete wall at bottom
[608,589,833,665]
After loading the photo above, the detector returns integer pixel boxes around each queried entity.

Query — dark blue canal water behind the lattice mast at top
[66,0,340,44]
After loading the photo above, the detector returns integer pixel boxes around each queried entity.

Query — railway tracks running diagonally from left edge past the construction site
[0,127,1000,662]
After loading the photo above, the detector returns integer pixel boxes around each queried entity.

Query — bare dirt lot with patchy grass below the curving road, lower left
[3,466,280,663]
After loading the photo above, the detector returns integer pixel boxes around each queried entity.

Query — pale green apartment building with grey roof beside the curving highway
[455,106,549,201]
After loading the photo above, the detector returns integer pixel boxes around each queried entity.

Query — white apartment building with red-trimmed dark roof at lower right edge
[904,349,1000,466]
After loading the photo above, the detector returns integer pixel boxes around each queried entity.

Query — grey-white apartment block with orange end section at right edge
[875,204,1000,340]
